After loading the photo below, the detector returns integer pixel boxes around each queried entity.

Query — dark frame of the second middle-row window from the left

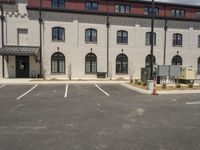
[85,28,98,44]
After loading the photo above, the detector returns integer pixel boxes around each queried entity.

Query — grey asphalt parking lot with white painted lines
[0,84,200,150]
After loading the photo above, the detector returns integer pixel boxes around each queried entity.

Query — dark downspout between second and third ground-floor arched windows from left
[106,0,110,78]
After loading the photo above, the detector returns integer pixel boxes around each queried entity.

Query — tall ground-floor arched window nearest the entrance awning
[51,52,65,73]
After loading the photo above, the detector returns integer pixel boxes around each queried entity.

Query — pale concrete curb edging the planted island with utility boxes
[121,83,200,95]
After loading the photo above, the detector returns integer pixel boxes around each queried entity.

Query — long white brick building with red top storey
[0,0,200,79]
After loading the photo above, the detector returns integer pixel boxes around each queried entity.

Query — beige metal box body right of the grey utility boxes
[180,67,196,80]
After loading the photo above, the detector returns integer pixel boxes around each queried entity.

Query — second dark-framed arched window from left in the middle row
[85,28,97,43]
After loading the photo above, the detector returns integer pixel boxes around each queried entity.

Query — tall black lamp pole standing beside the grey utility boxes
[150,0,155,80]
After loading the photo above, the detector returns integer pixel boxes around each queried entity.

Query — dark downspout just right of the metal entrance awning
[38,0,43,77]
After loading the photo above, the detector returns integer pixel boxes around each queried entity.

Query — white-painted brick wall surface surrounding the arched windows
[0,4,200,78]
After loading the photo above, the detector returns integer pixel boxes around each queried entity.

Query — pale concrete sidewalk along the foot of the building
[0,78,129,85]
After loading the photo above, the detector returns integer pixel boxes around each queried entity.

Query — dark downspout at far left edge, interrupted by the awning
[0,4,5,78]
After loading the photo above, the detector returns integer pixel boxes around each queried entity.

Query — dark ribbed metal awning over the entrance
[0,46,40,57]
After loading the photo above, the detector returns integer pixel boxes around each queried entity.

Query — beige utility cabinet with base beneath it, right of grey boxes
[180,67,196,83]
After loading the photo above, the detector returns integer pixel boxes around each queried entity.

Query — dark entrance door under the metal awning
[16,56,29,78]
